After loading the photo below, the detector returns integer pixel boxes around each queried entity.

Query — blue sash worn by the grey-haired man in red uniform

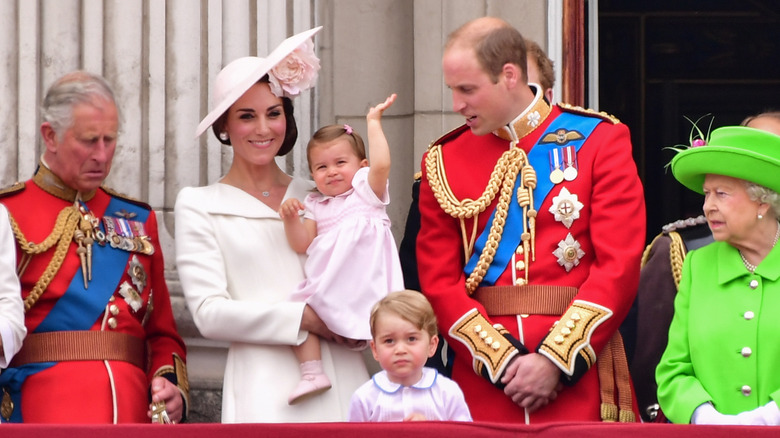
[0,197,150,423]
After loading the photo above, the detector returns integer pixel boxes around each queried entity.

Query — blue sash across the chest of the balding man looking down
[463,112,601,286]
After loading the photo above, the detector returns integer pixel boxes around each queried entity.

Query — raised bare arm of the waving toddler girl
[366,93,396,199]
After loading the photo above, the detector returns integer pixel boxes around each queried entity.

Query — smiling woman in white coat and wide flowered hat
[175,28,368,423]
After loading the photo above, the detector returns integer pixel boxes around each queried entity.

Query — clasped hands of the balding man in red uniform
[501,353,563,413]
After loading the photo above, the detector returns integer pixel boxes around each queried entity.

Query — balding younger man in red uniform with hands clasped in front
[417,17,645,424]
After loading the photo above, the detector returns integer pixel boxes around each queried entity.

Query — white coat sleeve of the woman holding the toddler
[175,189,308,345]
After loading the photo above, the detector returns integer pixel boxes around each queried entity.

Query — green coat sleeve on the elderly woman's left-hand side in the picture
[655,251,711,424]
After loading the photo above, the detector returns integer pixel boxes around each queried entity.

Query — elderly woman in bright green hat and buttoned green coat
[656,126,780,425]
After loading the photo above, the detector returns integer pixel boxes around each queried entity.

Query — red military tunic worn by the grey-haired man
[2,165,188,423]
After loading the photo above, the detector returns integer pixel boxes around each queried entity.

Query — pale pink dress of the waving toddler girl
[292,167,404,340]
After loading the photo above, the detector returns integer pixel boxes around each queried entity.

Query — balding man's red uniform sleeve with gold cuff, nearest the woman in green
[537,123,646,384]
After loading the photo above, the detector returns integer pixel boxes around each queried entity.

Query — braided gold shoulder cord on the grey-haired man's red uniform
[8,206,81,312]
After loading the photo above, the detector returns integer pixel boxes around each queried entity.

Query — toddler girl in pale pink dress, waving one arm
[279,94,404,404]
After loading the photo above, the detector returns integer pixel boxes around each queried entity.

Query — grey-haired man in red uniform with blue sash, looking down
[0,72,188,423]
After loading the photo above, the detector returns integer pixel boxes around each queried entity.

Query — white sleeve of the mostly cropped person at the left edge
[0,205,27,368]
